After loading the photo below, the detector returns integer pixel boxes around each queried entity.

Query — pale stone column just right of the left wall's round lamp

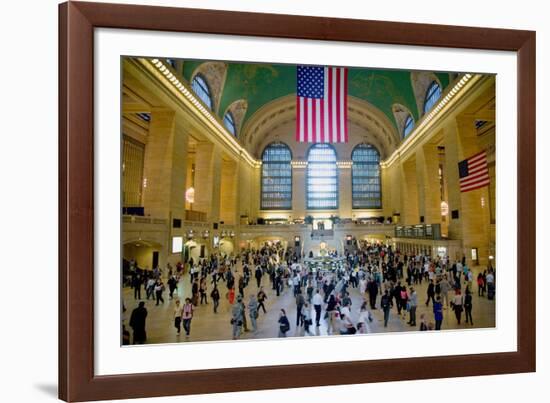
[193,142,222,222]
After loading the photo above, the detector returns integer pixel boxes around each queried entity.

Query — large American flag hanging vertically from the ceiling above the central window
[296,66,348,143]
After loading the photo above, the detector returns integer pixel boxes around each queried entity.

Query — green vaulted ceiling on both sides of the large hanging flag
[183,60,449,131]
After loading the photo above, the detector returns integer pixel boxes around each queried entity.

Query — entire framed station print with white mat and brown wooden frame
[59,2,535,401]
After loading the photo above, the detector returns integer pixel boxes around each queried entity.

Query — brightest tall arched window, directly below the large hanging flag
[306,143,338,210]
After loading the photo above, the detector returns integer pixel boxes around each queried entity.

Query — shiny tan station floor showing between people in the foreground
[123,267,495,344]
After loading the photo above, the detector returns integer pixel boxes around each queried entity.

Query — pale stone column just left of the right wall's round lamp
[416,144,441,224]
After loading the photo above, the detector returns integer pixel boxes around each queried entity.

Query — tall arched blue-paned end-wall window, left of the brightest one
[261,143,292,210]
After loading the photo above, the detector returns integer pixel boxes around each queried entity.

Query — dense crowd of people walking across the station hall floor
[123,242,495,344]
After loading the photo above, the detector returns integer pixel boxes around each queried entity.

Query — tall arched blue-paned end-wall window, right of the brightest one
[351,144,382,209]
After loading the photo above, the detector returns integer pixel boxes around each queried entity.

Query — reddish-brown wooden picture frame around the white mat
[59,2,536,401]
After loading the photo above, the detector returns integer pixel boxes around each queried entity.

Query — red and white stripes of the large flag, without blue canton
[296,67,348,143]
